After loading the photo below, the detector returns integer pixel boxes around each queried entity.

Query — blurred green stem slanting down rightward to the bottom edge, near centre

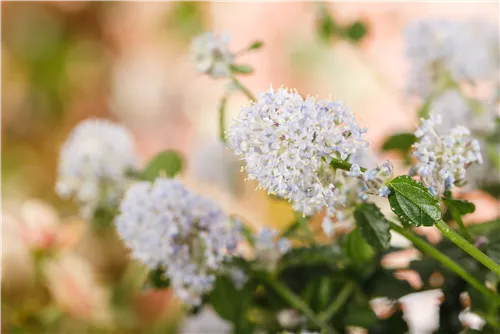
[262,275,338,334]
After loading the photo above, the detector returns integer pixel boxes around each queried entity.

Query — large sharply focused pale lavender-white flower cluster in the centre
[228,88,367,215]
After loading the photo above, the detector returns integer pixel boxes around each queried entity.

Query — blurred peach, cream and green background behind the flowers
[0,0,499,333]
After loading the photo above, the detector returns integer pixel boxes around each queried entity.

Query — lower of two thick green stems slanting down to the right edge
[390,222,500,302]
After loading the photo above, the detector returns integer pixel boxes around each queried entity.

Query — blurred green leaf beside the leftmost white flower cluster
[141,151,183,182]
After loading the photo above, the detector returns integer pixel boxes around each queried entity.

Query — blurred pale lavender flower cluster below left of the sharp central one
[115,178,240,305]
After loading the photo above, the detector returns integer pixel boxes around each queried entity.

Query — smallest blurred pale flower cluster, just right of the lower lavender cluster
[254,227,292,270]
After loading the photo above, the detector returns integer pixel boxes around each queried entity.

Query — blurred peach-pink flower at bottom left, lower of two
[43,252,111,325]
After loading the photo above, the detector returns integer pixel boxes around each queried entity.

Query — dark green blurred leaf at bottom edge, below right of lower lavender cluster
[208,275,254,334]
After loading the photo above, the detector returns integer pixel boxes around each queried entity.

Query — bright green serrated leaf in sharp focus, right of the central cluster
[388,175,441,226]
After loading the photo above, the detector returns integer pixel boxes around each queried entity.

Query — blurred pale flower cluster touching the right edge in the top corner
[405,19,499,98]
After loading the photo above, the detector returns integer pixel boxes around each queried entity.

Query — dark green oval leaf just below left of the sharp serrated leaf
[354,203,391,249]
